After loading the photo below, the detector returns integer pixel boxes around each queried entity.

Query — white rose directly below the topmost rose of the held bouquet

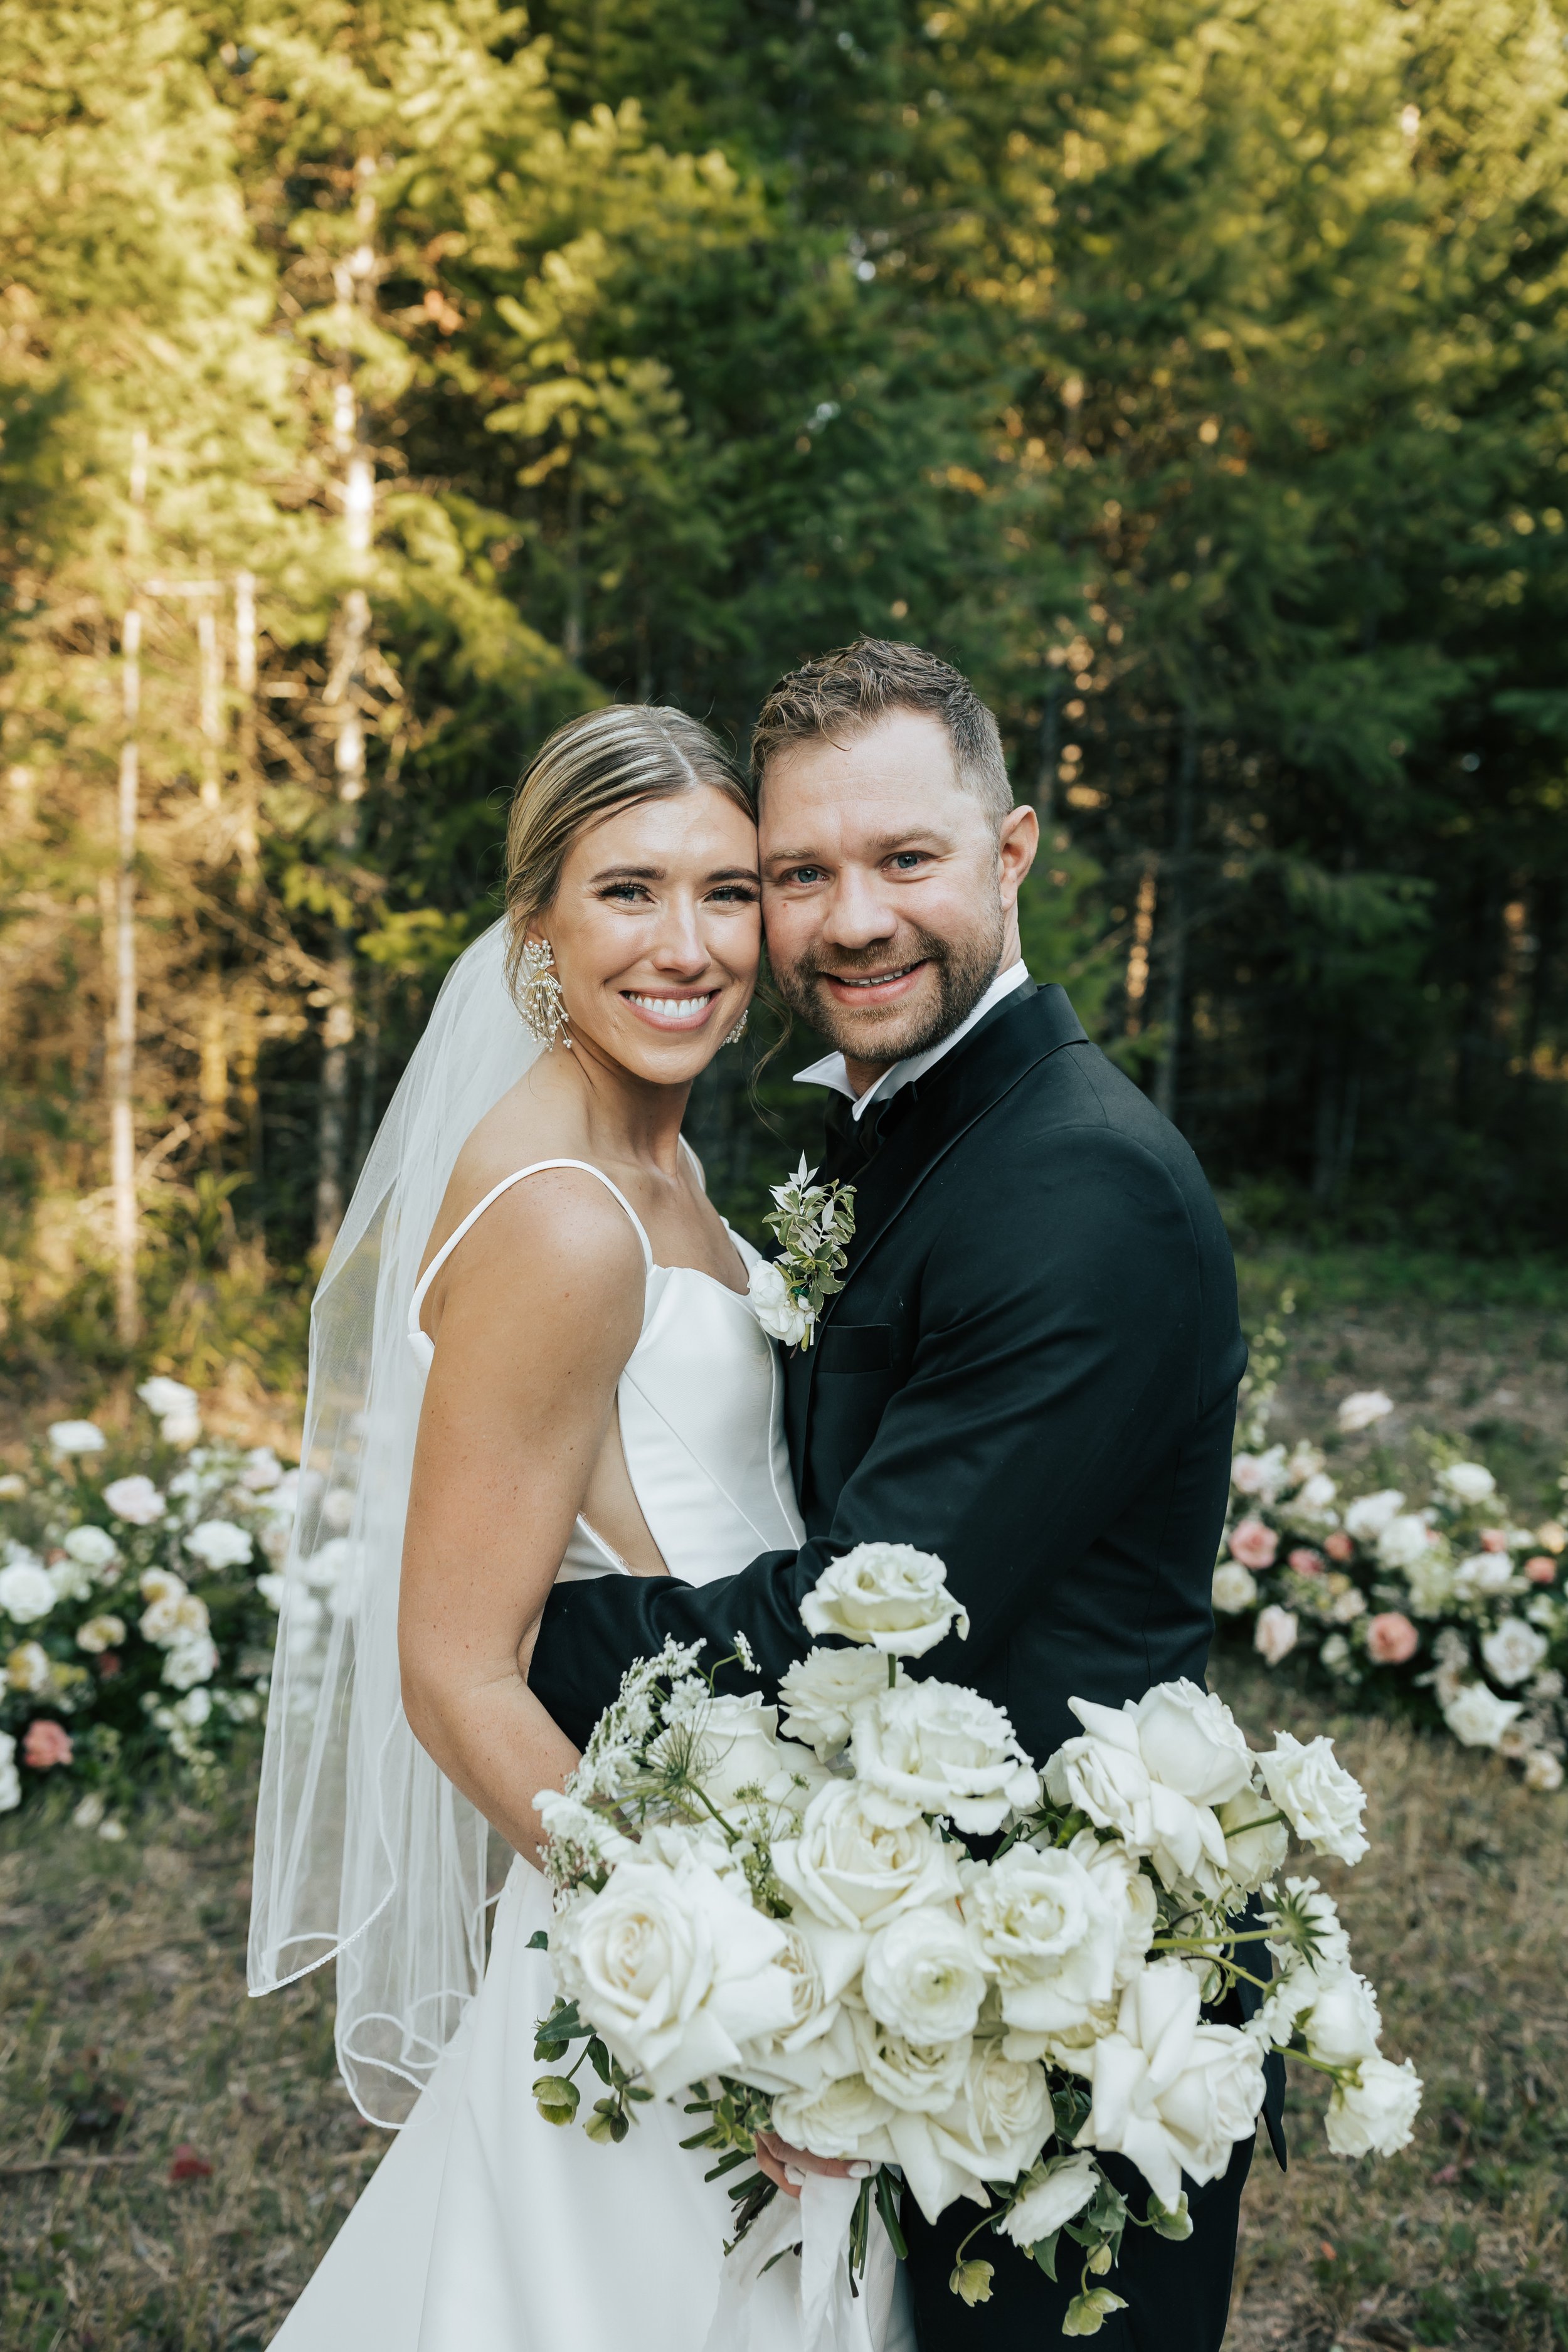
[851,1682,1039,1837]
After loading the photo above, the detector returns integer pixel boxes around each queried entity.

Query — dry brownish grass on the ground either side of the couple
[0,1663,1568,2352]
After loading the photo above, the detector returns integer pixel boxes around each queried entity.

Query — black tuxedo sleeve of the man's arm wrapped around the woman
[529,1126,1237,1745]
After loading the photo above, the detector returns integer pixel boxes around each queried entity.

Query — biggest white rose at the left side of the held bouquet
[553,1856,795,2098]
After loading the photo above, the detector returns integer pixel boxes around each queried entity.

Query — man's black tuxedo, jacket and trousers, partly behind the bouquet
[529,988,1278,2352]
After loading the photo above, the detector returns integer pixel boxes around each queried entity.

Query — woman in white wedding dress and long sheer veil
[249,706,905,2352]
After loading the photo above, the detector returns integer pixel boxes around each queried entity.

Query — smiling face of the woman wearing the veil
[529,783,761,1087]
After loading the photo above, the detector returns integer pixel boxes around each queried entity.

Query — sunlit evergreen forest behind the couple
[0,0,1568,1383]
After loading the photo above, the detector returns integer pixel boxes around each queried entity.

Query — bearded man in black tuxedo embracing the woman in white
[529,640,1276,2352]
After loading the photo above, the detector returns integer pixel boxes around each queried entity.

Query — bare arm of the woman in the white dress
[397,1172,644,1856]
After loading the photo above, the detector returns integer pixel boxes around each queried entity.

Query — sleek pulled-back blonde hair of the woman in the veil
[506,703,757,993]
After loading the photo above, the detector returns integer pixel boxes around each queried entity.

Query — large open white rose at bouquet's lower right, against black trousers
[1074,1959,1264,2206]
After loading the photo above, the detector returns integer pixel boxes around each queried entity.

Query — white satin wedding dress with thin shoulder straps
[273,1160,912,2352]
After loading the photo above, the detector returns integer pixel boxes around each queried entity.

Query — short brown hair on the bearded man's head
[752,637,1013,825]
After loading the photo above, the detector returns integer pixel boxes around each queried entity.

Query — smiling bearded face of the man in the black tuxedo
[760,711,1037,1089]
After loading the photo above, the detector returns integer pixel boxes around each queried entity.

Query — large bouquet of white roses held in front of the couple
[534,1543,1420,2336]
